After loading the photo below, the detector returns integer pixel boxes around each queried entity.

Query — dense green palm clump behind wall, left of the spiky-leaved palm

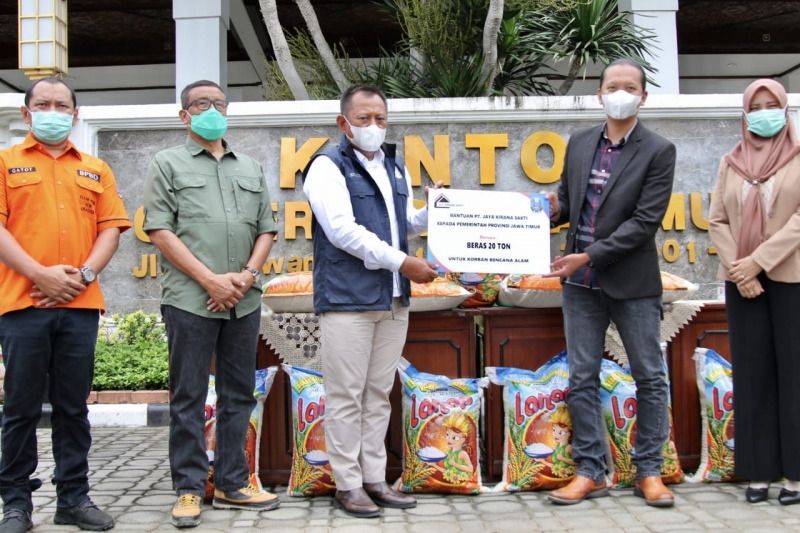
[365,0,556,98]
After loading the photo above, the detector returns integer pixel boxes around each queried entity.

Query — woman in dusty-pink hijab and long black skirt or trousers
[709,79,800,505]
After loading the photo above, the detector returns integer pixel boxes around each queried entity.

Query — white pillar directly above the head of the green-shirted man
[172,0,230,103]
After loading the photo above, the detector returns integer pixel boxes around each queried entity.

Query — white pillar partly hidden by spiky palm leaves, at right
[619,0,680,94]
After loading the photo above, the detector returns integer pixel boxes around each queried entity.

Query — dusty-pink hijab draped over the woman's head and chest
[725,79,800,258]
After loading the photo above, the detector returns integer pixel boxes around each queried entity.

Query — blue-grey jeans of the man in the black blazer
[564,284,669,480]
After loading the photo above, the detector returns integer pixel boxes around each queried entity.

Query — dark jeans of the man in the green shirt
[161,305,261,496]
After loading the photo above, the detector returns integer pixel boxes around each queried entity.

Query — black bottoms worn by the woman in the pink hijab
[725,273,800,481]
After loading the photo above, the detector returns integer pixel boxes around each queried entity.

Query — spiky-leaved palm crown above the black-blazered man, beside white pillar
[524,0,655,95]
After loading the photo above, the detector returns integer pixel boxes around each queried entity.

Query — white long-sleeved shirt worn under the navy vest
[303,145,428,296]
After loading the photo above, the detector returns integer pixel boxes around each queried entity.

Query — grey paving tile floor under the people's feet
[9,427,800,533]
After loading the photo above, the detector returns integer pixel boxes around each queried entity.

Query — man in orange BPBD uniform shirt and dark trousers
[0,78,131,532]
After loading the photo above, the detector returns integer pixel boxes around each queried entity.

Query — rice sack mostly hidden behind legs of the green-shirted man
[203,366,278,502]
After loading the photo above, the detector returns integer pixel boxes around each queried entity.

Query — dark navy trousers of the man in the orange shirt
[0,307,99,512]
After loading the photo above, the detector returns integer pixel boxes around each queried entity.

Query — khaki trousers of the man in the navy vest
[320,298,408,490]
